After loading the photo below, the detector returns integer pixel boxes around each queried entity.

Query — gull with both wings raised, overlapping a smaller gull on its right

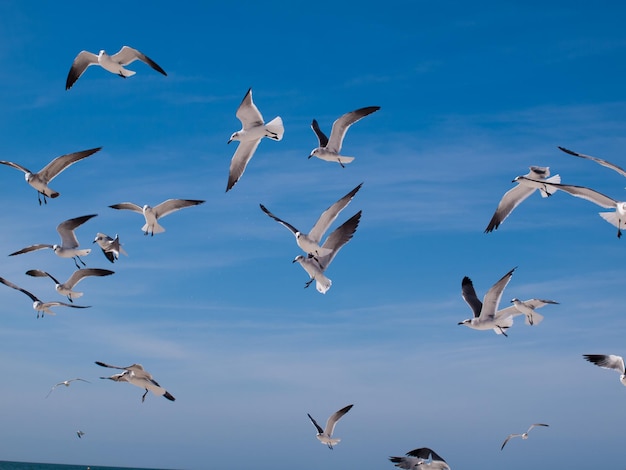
[458,268,517,336]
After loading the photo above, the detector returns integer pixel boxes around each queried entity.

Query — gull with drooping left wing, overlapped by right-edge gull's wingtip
[485,166,561,233]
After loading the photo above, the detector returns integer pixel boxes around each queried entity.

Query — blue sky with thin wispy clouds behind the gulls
[0,1,626,470]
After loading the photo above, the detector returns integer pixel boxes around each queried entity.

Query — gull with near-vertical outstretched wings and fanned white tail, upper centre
[226,88,285,192]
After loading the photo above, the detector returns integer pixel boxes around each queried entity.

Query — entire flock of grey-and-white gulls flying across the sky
[0,46,626,469]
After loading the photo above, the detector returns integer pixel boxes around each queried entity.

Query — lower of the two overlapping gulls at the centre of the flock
[292,211,361,294]
